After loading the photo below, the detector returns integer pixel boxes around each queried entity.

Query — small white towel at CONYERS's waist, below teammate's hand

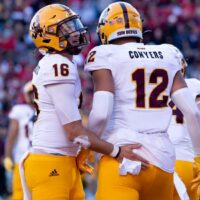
[119,158,142,176]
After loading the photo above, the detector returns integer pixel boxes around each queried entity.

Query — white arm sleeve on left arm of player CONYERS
[88,91,114,137]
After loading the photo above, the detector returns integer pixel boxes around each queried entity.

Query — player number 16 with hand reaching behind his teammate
[23,4,148,200]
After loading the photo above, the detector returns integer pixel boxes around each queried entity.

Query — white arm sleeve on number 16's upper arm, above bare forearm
[46,84,81,125]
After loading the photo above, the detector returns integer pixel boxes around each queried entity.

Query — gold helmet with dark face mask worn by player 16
[29,4,88,55]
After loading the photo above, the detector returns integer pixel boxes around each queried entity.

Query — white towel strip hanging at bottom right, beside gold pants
[174,172,190,200]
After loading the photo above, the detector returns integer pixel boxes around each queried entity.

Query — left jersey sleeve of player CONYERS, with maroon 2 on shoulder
[84,45,113,72]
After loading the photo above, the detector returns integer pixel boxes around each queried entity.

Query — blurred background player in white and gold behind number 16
[4,81,34,200]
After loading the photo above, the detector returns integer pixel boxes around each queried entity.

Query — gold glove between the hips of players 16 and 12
[76,149,94,174]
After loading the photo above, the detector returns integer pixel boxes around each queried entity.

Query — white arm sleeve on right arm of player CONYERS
[171,88,200,155]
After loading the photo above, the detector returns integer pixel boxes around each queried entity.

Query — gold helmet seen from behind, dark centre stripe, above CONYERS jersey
[97,2,143,44]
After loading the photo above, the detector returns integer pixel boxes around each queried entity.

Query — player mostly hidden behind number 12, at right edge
[168,57,200,200]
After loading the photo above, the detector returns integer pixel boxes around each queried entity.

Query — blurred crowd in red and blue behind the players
[0,0,200,198]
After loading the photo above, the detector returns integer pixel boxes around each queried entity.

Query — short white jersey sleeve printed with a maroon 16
[39,55,78,85]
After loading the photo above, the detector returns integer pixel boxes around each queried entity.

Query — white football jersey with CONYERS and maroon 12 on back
[85,43,181,172]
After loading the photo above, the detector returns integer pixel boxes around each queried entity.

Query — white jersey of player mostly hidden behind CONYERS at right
[168,78,200,162]
